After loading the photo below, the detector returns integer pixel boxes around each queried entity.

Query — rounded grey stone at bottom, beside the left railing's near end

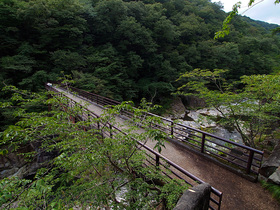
[173,183,211,210]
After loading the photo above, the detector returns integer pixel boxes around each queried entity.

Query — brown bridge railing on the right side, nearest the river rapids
[48,83,263,177]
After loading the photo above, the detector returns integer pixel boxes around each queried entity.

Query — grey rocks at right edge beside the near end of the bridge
[260,142,280,184]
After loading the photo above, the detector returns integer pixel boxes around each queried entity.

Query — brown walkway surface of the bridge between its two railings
[53,88,280,210]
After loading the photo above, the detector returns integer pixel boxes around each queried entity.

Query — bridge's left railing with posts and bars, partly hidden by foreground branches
[46,86,223,210]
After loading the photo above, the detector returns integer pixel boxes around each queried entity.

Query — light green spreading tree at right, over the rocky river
[177,69,280,147]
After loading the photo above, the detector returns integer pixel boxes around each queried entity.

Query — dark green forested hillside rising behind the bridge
[0,0,280,103]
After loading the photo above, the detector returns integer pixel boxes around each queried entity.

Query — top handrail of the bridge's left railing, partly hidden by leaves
[46,85,223,210]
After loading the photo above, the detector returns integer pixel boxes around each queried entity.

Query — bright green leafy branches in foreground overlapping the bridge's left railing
[0,87,187,209]
